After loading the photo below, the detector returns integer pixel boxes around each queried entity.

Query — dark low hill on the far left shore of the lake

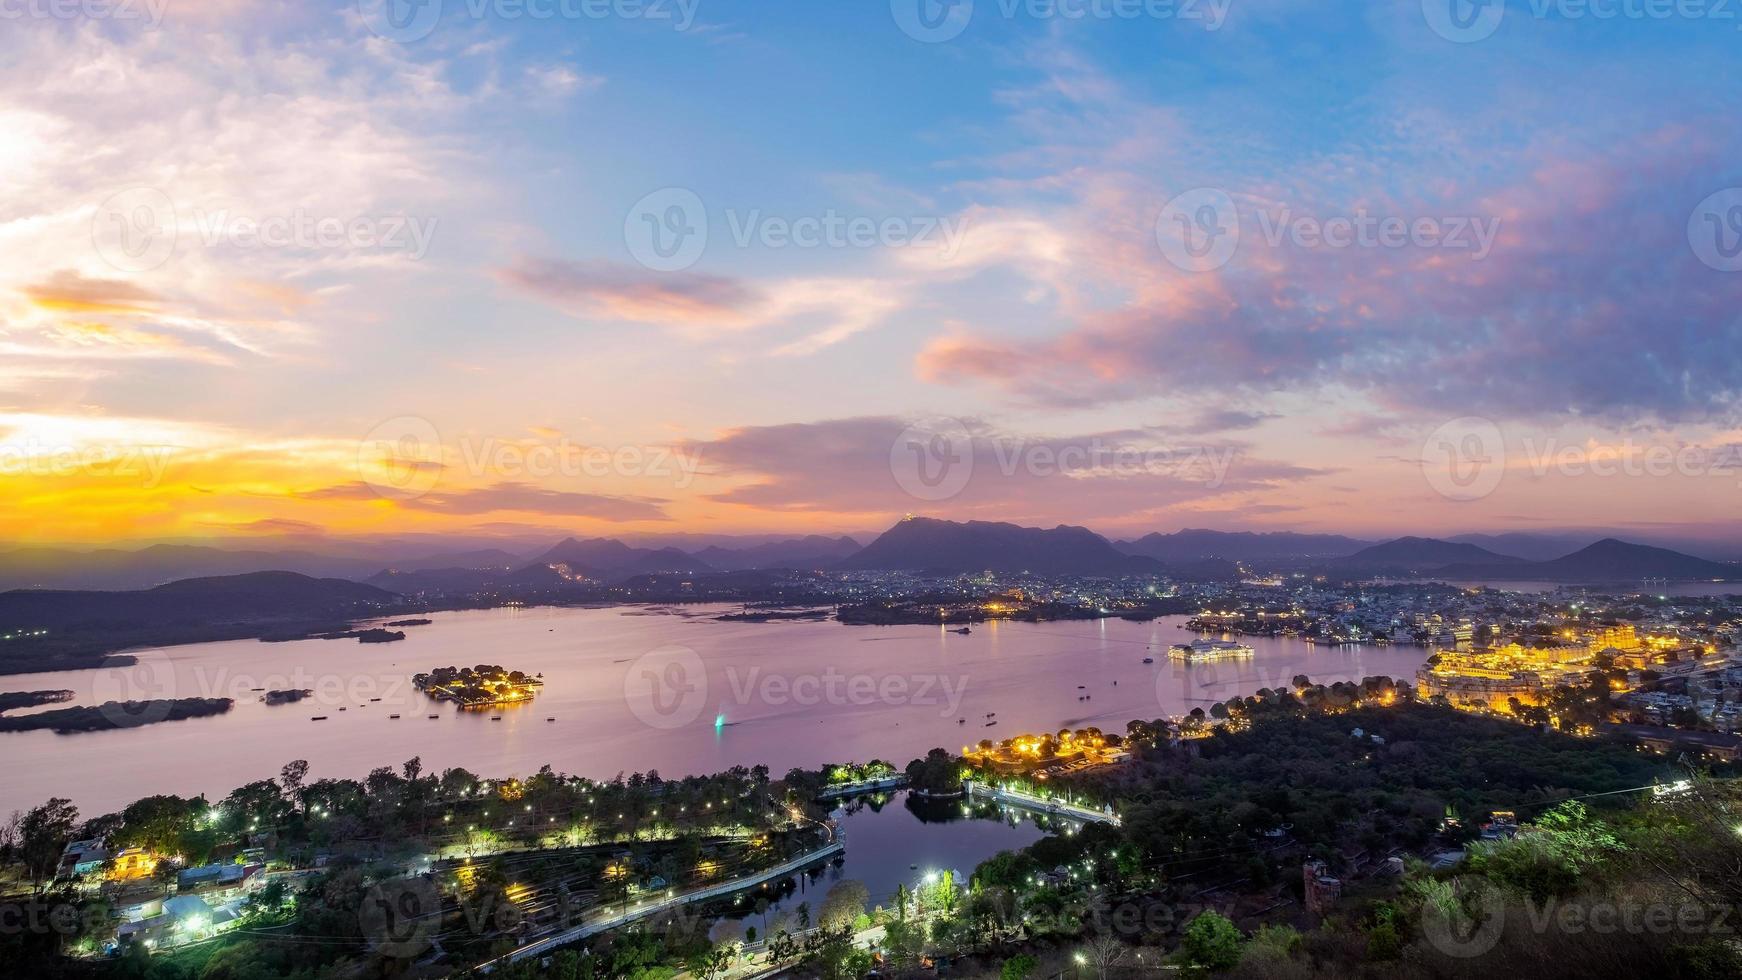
[0,571,401,632]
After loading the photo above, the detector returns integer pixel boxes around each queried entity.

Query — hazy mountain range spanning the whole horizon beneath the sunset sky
[0,517,1739,595]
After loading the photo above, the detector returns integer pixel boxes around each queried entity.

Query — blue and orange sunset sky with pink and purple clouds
[0,0,1742,545]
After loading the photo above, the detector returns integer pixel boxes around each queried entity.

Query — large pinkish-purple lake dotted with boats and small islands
[0,606,1427,815]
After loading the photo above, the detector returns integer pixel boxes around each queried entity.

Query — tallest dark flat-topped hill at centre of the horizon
[836,517,1160,574]
